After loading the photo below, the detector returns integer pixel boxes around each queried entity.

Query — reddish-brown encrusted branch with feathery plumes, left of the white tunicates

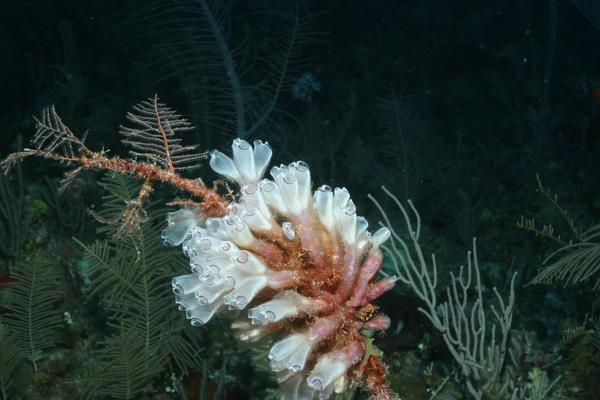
[0,101,228,216]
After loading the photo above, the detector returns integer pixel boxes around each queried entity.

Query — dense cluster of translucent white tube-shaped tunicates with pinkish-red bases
[163,139,395,399]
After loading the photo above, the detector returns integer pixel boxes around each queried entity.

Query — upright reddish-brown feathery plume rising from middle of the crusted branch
[119,95,206,172]
